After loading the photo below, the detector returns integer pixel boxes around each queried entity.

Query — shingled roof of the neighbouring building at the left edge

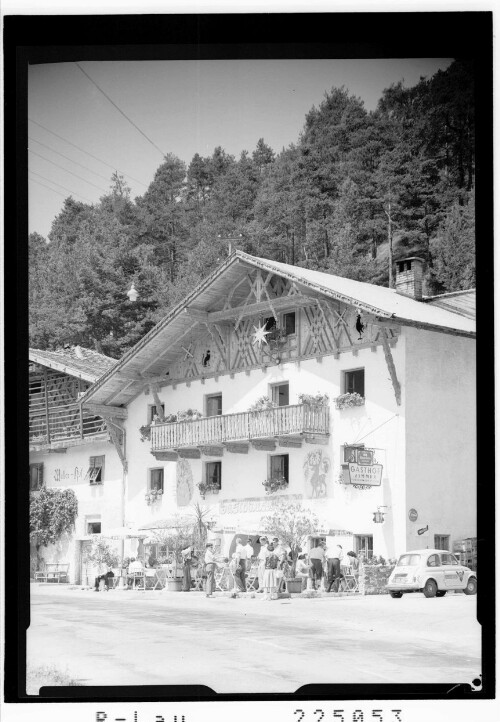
[29,346,117,383]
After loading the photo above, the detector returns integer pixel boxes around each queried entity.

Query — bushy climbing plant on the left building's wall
[30,487,78,550]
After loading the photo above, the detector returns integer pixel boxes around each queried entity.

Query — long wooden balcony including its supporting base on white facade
[151,404,330,459]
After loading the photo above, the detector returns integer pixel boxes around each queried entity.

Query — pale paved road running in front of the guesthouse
[27,585,480,693]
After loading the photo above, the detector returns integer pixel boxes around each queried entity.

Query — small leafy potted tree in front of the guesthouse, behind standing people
[261,503,318,578]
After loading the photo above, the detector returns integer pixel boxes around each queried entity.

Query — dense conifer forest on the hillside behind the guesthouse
[29,61,475,358]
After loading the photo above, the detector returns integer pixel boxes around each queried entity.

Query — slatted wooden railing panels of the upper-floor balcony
[151,404,330,452]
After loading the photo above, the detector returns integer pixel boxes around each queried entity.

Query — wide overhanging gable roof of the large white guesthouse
[83,251,475,406]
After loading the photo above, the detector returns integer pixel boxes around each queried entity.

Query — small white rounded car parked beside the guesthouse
[387,549,477,598]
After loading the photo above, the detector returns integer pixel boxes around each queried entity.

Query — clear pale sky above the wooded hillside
[28,58,452,237]
